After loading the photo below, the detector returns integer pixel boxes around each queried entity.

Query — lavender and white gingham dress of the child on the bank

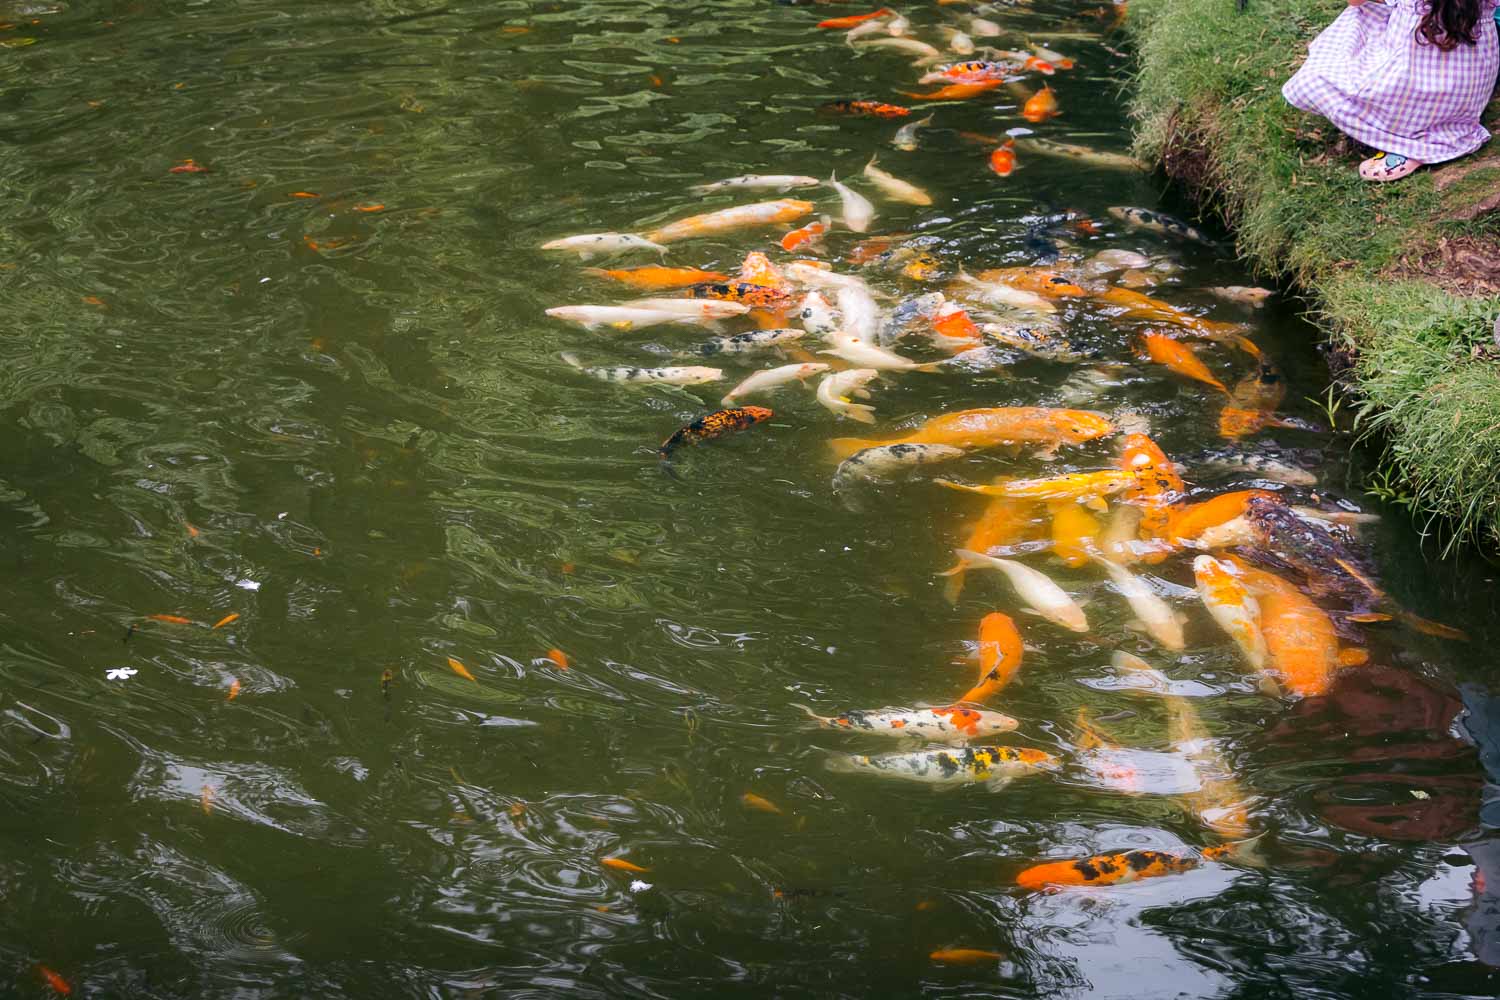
[1281,0,1500,163]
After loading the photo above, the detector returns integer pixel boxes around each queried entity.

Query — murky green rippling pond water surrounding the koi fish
[0,0,1500,997]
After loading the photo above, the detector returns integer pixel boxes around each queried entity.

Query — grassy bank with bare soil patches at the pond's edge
[1128,0,1500,546]
